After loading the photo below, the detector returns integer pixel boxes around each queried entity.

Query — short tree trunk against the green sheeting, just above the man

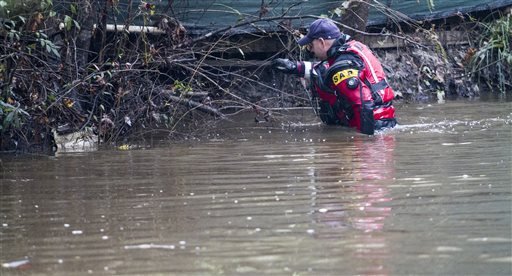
[340,0,370,43]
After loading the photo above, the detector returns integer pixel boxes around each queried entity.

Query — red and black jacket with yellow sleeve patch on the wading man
[312,39,396,134]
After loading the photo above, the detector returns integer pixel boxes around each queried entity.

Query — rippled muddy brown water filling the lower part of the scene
[0,101,512,275]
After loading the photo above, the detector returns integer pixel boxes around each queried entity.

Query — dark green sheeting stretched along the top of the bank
[101,0,512,36]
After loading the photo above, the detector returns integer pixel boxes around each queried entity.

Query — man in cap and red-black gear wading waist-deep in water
[272,18,396,135]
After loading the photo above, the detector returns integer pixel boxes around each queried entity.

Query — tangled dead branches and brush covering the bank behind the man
[0,0,510,152]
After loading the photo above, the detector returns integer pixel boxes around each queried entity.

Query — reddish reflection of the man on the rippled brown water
[302,134,395,275]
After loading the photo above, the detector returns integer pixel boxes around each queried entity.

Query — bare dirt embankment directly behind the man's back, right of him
[376,46,482,101]
